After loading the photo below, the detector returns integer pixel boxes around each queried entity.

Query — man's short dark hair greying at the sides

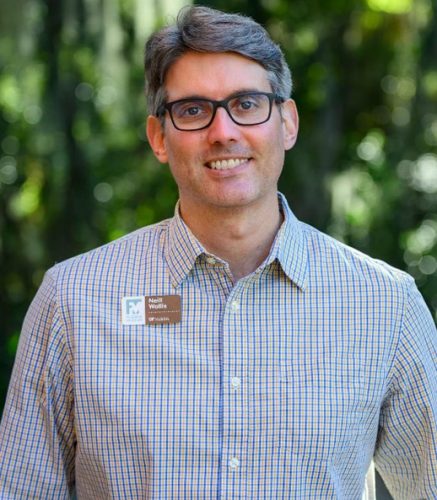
[144,5,292,115]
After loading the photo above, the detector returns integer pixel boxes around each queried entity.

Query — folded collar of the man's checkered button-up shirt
[164,193,308,290]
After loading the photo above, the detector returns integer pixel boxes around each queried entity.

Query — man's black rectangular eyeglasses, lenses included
[156,92,285,131]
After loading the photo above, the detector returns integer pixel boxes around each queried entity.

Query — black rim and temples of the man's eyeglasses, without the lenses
[156,91,286,132]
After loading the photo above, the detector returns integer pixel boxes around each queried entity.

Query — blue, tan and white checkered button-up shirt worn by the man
[0,195,437,500]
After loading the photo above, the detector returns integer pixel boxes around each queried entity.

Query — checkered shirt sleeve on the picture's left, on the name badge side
[0,271,75,499]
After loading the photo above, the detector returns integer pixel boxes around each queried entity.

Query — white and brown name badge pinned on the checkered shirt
[121,295,182,325]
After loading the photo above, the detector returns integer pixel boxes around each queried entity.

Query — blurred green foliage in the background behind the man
[0,0,437,416]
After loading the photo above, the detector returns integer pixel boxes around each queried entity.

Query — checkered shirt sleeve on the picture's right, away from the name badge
[375,280,437,500]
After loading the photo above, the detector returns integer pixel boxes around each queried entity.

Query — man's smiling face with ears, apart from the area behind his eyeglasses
[147,52,298,214]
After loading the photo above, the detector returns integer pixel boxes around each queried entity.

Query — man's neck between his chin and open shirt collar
[180,195,282,282]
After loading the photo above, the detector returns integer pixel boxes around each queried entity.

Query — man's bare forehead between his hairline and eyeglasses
[165,52,271,101]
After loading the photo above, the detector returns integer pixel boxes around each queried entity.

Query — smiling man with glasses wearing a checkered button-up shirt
[0,7,437,500]
